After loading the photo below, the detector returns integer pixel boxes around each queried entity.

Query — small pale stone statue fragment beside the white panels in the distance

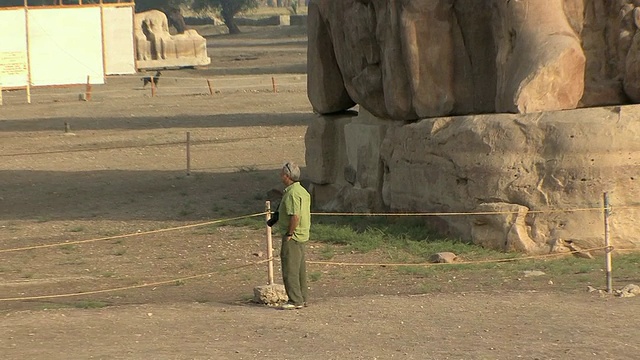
[134,10,211,69]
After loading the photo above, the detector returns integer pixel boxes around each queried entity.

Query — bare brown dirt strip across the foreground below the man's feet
[0,292,640,360]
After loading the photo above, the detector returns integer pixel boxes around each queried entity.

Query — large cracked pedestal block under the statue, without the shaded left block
[381,106,640,252]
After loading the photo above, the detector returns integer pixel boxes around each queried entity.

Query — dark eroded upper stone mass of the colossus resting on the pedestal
[308,0,640,120]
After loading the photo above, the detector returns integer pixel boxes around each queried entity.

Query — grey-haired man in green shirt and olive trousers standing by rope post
[267,162,311,310]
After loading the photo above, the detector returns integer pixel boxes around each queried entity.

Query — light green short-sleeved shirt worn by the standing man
[278,182,311,242]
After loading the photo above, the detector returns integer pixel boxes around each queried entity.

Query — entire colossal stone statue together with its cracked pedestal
[306,0,640,253]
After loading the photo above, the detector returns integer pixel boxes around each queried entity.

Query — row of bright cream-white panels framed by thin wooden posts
[0,4,136,88]
